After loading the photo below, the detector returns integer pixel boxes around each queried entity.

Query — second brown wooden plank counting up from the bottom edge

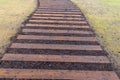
[1,53,110,64]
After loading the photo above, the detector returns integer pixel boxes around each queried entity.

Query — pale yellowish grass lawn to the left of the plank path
[0,0,36,53]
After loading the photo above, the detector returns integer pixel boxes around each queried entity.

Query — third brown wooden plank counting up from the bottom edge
[10,43,102,50]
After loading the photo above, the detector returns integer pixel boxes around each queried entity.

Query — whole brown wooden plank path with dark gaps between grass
[0,0,120,80]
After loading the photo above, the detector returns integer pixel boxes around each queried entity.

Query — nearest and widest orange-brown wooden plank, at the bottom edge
[0,69,119,80]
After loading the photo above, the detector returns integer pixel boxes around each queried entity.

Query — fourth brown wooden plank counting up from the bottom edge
[17,35,97,41]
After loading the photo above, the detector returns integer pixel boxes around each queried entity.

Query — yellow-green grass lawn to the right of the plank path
[72,0,120,71]
